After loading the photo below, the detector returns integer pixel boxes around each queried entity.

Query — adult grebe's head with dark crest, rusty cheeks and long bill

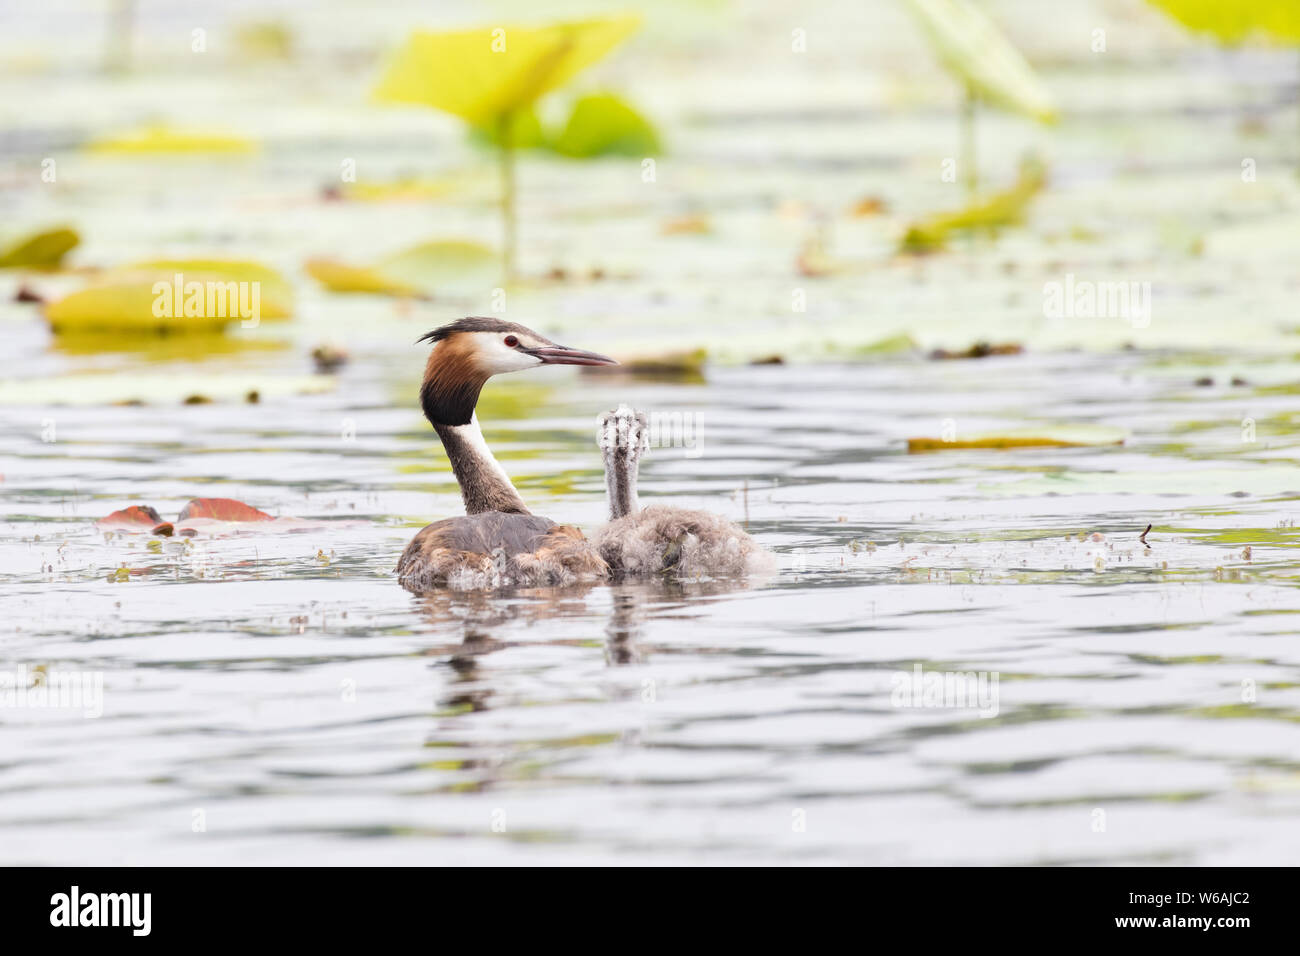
[417,317,618,425]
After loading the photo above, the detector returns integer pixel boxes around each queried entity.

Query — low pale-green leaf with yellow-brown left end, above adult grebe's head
[306,239,497,295]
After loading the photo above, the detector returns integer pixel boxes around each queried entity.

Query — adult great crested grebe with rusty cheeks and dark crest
[397,319,618,592]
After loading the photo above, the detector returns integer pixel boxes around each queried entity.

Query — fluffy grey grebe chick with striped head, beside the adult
[593,405,775,578]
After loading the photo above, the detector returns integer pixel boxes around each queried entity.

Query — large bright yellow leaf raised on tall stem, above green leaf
[374,16,641,126]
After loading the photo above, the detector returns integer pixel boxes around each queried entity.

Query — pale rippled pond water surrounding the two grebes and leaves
[0,4,1300,864]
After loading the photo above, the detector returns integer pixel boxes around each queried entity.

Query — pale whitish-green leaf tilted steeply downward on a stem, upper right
[907,0,1056,122]
